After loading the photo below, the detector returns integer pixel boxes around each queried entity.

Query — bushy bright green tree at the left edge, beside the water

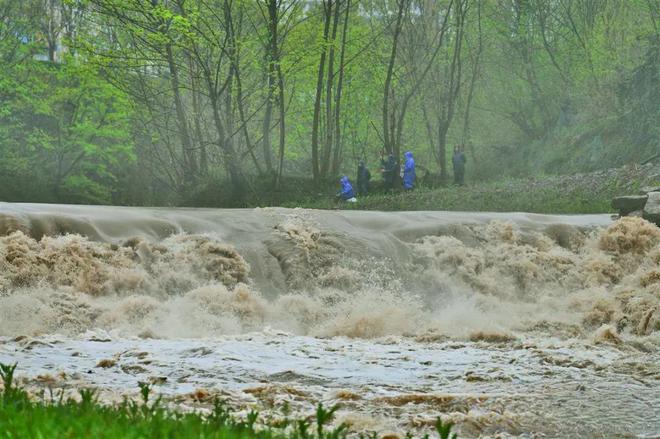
[0,54,135,203]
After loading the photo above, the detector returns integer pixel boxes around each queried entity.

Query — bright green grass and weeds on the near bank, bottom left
[0,364,456,439]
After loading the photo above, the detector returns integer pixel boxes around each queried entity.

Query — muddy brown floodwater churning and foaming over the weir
[0,204,660,437]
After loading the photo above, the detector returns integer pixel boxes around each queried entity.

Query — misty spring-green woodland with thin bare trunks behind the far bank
[0,0,660,205]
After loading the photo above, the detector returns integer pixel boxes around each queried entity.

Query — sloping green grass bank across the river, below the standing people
[283,167,660,214]
